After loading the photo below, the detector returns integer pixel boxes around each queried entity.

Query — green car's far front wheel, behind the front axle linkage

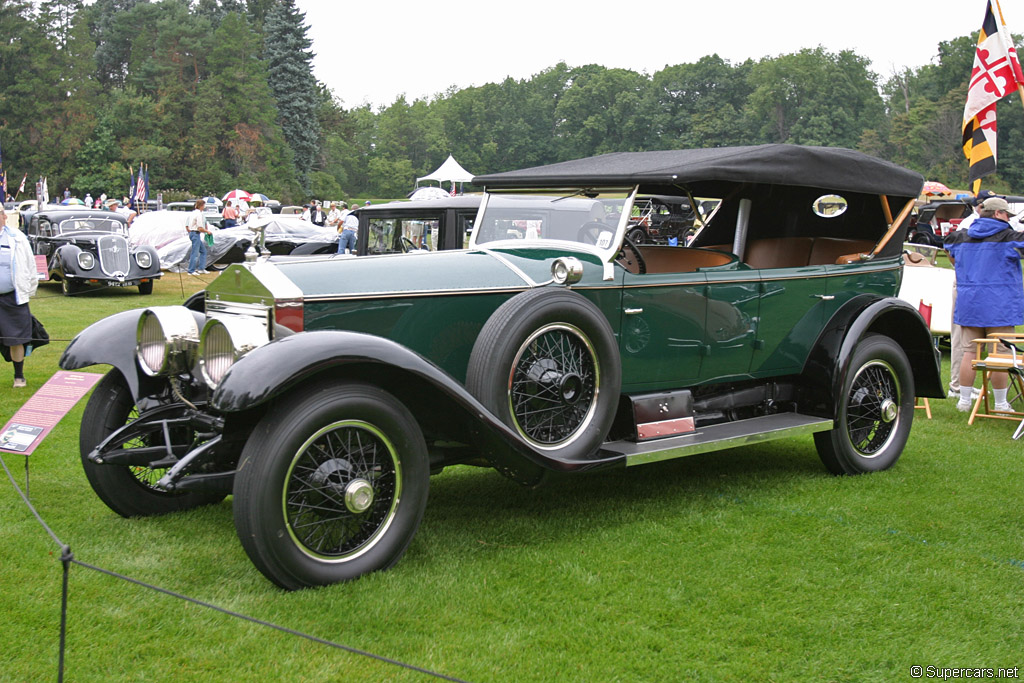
[79,370,224,517]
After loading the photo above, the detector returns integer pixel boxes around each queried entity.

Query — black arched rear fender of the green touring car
[801,294,945,417]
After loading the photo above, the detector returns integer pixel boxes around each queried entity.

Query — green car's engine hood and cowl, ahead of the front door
[279,249,623,381]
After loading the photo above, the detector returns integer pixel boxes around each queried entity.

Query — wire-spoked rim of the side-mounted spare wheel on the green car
[509,324,600,446]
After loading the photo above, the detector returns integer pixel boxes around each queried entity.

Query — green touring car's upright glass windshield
[470,190,633,255]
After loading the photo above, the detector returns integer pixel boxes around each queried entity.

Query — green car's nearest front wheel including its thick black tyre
[234,383,429,590]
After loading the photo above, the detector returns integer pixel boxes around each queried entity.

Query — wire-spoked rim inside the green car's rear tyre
[847,360,900,458]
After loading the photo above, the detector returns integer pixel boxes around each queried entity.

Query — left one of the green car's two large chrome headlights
[135,306,199,377]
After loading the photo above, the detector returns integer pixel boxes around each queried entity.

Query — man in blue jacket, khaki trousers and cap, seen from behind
[945,197,1024,413]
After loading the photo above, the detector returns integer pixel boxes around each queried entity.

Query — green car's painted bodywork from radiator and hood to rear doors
[208,247,901,392]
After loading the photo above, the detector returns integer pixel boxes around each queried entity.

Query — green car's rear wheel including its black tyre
[814,335,913,474]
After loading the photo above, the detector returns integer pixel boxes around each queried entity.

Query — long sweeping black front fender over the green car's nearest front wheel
[210,331,622,483]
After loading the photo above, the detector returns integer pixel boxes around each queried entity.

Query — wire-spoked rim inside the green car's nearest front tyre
[284,421,401,560]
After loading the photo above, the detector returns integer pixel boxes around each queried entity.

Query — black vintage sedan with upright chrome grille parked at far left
[27,208,160,295]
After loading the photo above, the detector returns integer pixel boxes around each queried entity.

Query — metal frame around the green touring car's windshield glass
[468,185,640,263]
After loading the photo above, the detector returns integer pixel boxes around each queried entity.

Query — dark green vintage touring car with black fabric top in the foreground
[61,145,944,589]
